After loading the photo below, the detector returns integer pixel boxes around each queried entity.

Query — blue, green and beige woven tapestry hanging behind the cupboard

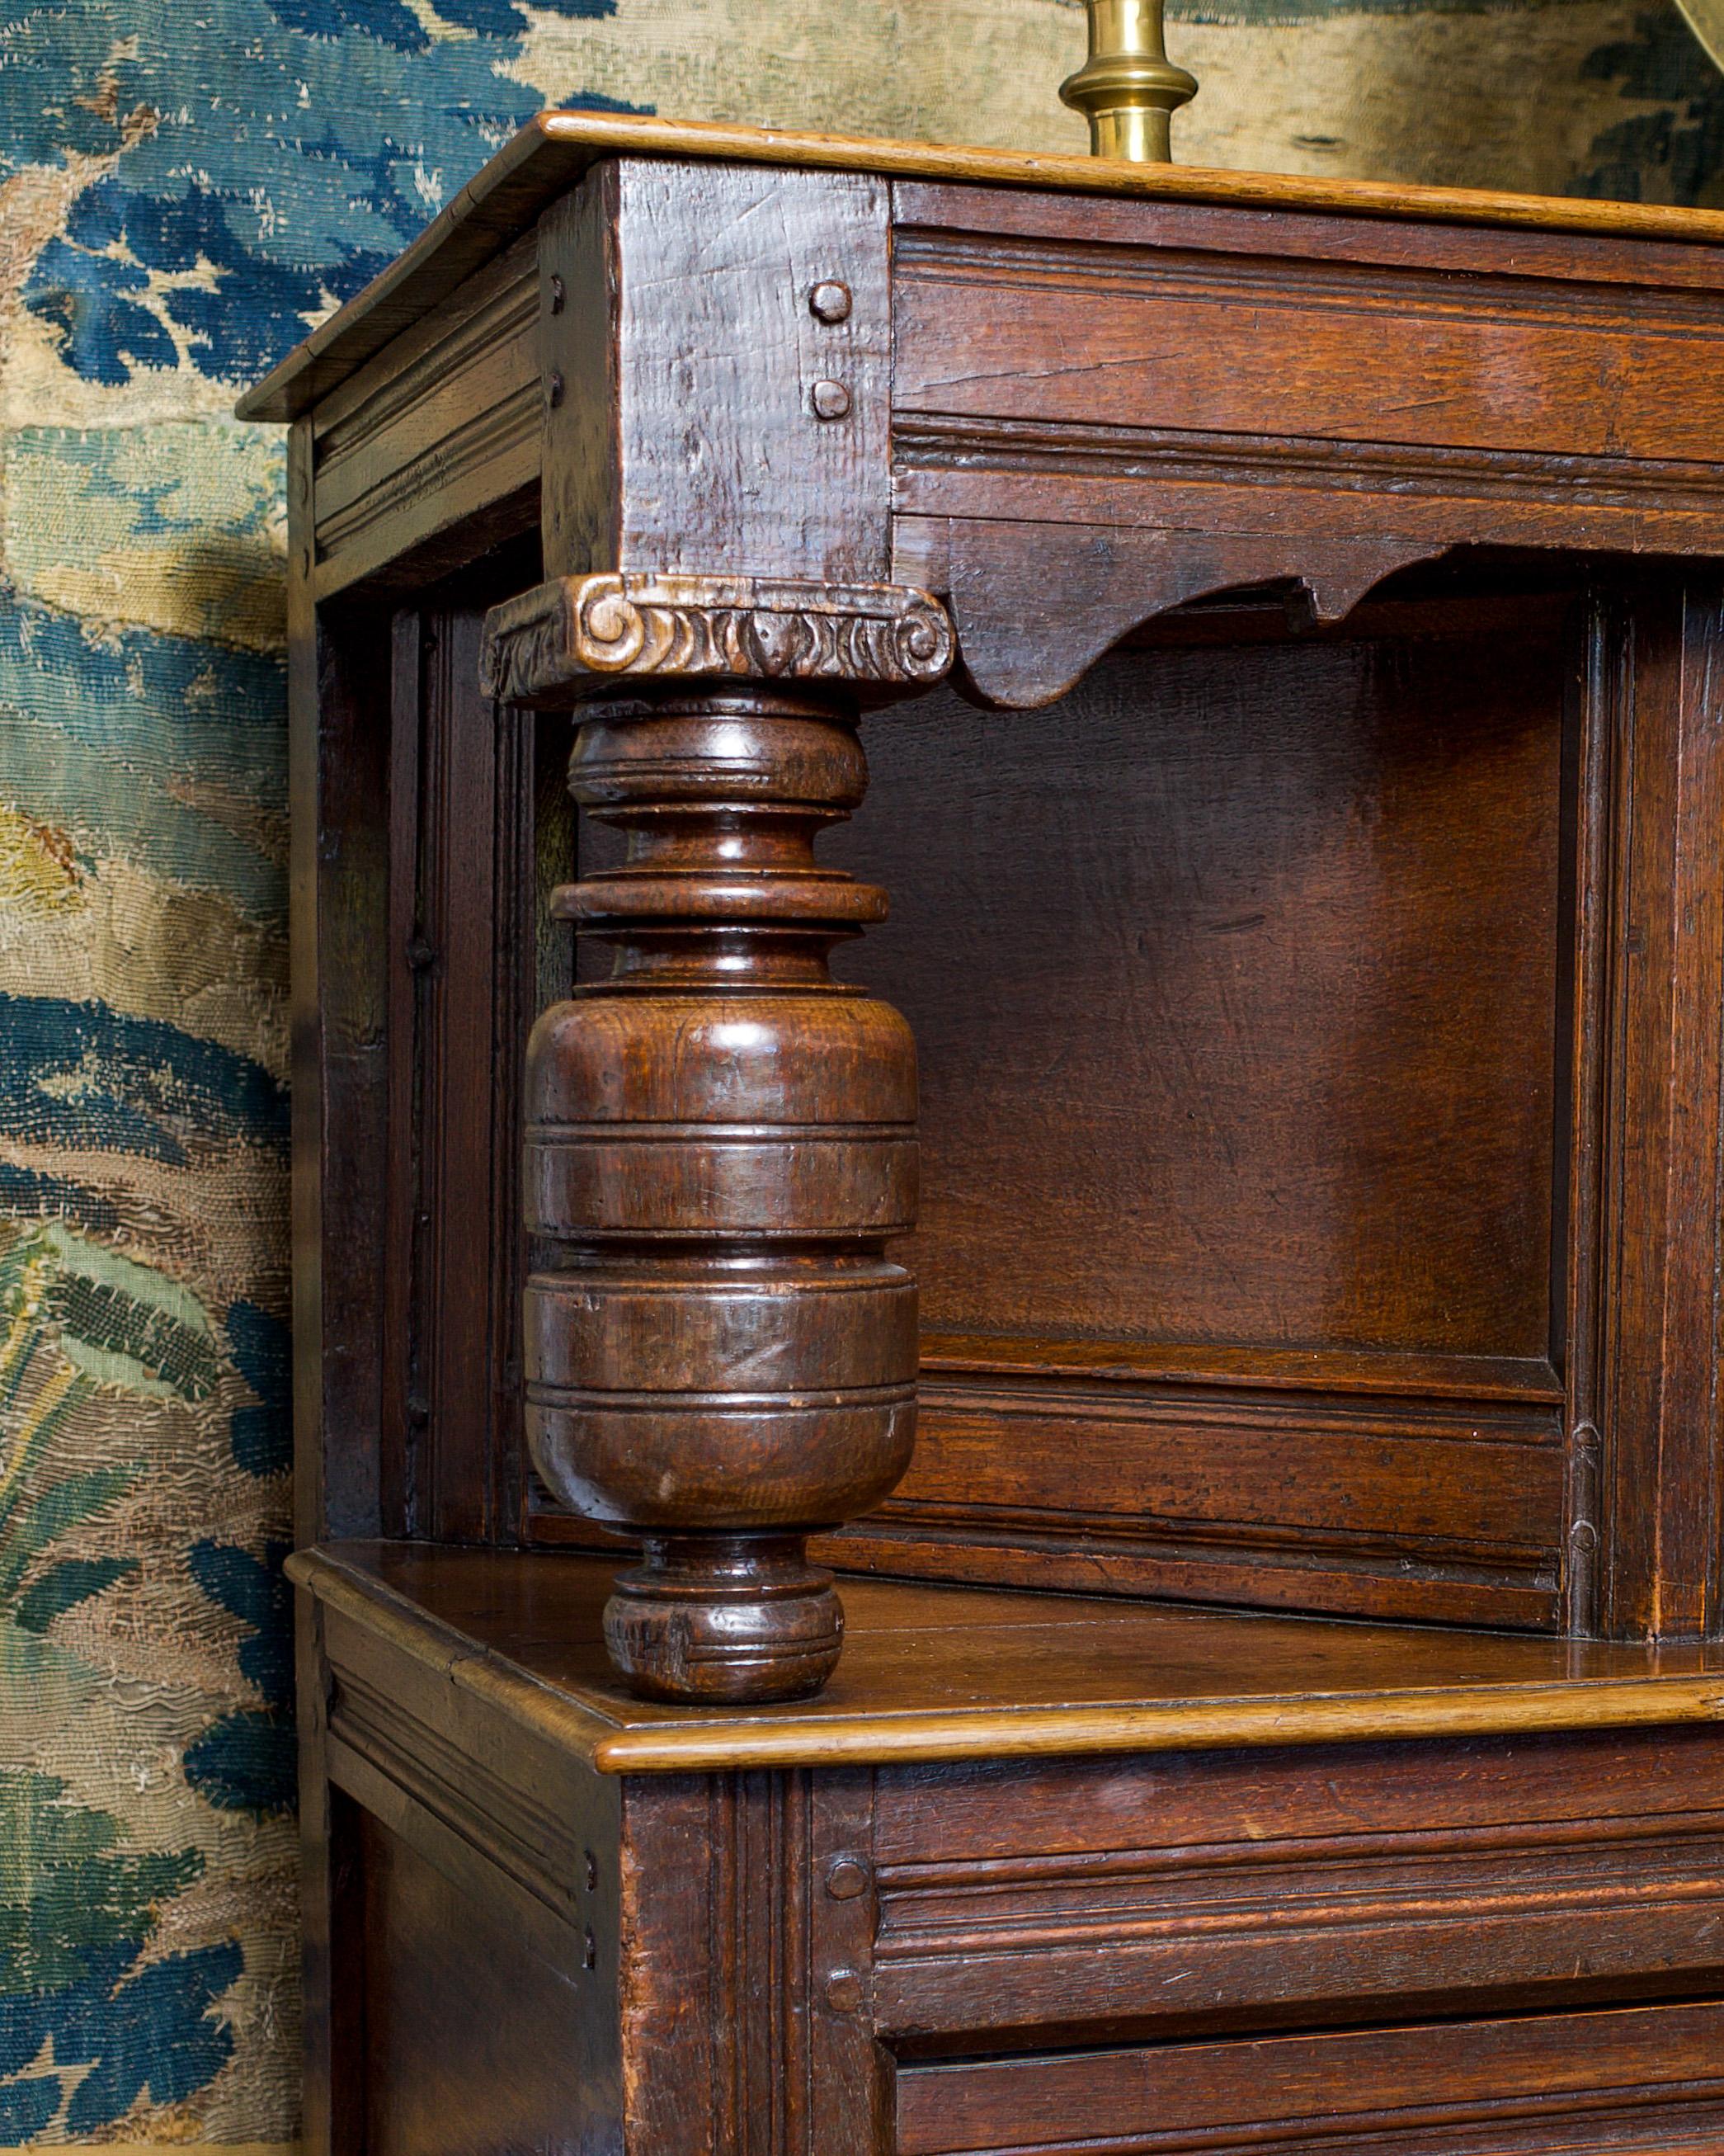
[0,0,1724,2148]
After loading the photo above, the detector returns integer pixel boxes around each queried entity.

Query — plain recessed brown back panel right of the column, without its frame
[827,620,1562,1358]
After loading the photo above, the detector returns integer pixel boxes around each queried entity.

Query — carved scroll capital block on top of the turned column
[481,571,954,703]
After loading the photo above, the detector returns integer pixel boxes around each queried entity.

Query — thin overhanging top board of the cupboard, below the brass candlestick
[235,108,1724,421]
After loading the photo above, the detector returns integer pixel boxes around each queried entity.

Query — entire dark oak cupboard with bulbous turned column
[242,112,1724,2156]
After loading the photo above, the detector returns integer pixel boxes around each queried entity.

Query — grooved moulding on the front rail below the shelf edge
[875,1811,1724,2037]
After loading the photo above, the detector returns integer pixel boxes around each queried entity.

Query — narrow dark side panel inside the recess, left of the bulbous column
[379,550,551,1541]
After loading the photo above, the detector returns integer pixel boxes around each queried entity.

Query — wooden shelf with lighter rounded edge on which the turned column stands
[289,1541,1724,1774]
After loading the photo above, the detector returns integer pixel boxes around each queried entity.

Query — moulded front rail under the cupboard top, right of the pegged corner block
[893,196,1724,464]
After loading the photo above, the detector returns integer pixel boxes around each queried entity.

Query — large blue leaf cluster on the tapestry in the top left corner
[0,0,638,384]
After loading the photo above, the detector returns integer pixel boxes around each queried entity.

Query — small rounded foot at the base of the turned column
[605,1535,845,1705]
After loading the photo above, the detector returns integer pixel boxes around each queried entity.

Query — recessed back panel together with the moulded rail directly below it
[830,599,1571,1624]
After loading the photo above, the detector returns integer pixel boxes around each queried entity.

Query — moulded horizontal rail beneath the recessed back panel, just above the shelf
[819,1337,1565,1625]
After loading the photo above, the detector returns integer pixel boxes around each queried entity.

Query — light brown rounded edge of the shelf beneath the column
[286,1548,1724,1774]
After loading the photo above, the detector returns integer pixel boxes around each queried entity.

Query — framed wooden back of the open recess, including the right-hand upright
[504,560,1724,1639]
